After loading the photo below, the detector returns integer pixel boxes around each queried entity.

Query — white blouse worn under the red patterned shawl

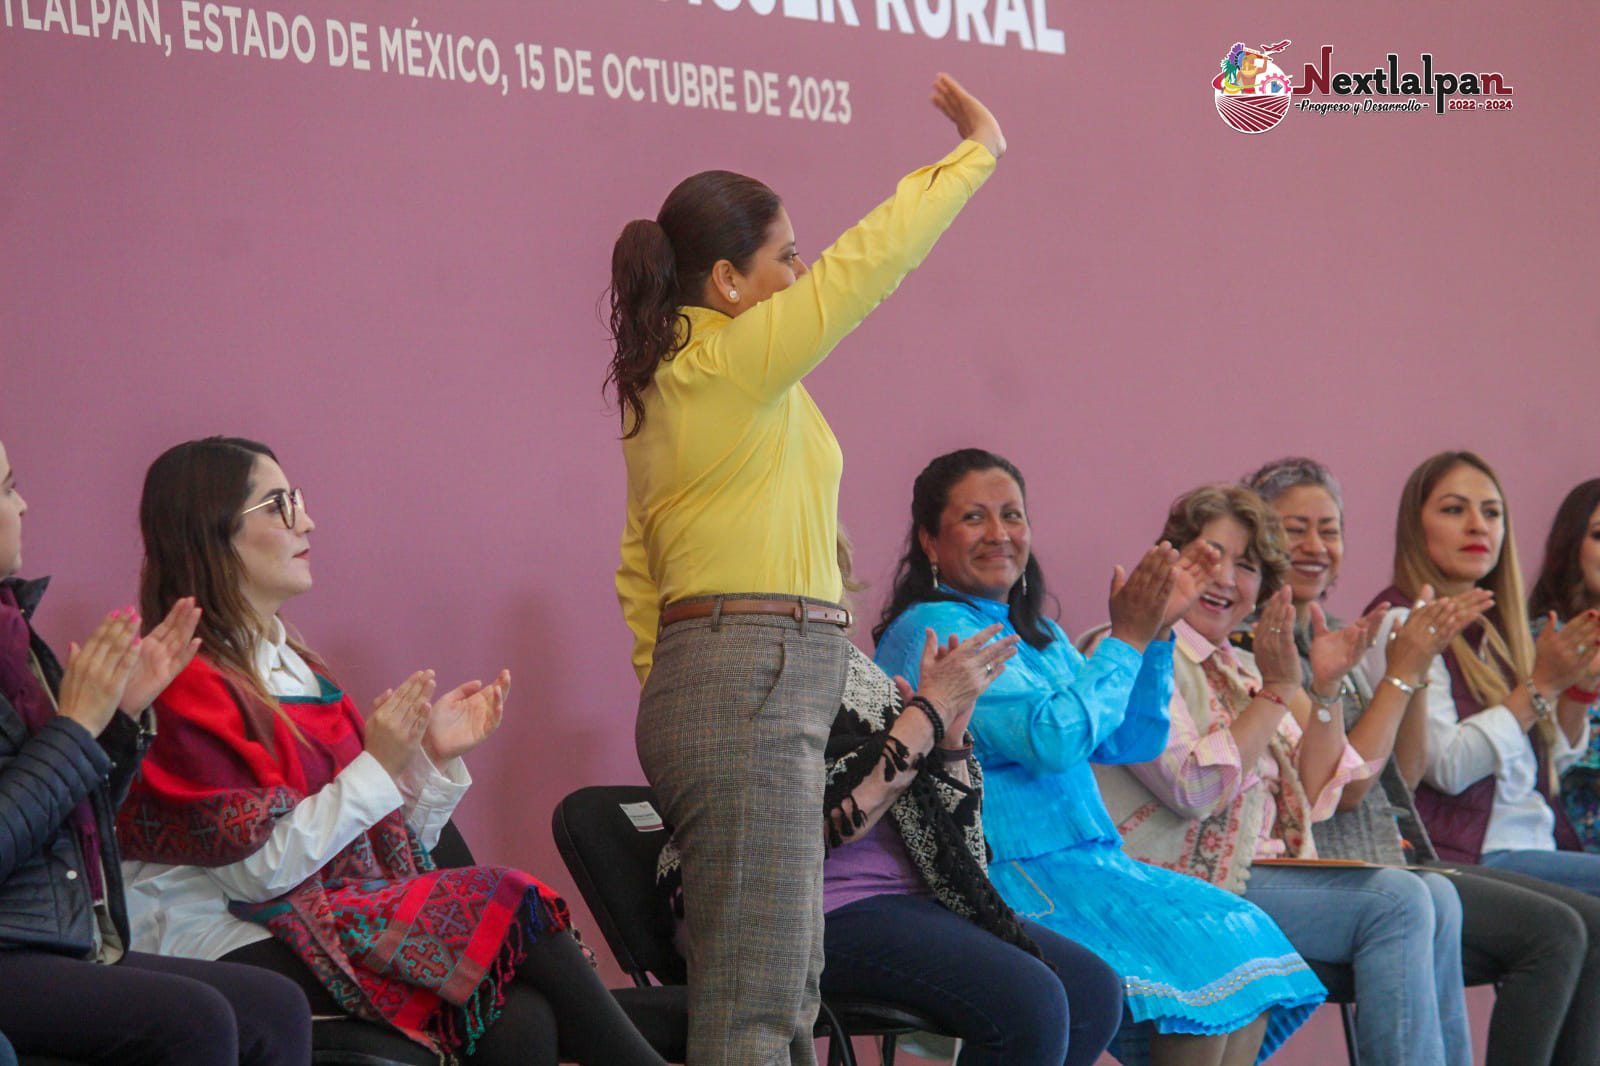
[122,619,472,959]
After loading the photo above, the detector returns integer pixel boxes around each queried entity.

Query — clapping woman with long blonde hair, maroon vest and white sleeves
[1363,451,1600,896]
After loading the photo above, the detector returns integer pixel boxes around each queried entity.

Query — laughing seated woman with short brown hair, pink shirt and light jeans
[1096,483,1472,1066]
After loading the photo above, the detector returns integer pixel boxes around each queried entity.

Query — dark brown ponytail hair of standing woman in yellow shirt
[605,170,782,439]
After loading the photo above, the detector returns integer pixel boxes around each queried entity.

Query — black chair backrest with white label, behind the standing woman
[550,784,688,986]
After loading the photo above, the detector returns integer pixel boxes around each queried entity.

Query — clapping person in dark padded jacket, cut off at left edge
[0,435,310,1066]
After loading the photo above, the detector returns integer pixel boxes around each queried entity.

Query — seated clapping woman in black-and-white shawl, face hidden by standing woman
[661,530,1122,1066]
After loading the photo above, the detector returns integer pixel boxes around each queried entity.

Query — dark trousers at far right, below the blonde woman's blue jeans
[1446,864,1600,1066]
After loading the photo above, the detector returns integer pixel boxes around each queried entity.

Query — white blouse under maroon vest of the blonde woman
[1358,607,1589,852]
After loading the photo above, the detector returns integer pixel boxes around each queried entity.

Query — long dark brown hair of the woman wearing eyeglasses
[139,437,315,751]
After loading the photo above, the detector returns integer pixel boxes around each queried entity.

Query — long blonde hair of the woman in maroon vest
[1394,451,1555,758]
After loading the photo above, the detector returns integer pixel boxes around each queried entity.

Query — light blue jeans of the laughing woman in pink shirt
[1245,866,1472,1066]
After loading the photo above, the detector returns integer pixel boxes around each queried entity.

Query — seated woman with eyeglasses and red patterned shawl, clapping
[118,437,662,1066]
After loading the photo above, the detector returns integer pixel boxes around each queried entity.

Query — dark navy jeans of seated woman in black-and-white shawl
[822,895,1122,1066]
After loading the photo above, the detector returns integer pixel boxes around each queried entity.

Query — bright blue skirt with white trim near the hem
[989,844,1326,1063]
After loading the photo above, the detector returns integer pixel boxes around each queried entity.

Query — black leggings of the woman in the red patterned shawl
[224,933,666,1066]
